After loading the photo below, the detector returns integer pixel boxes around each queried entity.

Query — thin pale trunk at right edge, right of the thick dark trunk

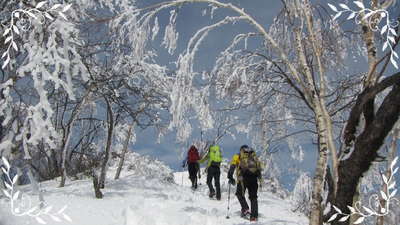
[376,122,400,225]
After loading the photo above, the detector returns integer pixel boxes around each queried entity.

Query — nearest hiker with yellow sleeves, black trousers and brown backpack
[228,145,262,221]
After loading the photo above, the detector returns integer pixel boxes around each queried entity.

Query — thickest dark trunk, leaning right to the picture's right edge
[332,84,400,225]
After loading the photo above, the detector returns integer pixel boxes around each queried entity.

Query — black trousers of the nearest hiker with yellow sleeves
[236,176,258,218]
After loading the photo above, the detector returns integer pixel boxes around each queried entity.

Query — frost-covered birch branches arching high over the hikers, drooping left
[126,0,314,142]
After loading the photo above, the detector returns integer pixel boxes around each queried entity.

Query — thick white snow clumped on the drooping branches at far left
[0,1,87,155]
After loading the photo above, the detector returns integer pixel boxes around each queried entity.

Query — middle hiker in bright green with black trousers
[199,145,222,200]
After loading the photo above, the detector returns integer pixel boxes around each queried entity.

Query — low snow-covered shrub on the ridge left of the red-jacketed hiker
[110,152,174,183]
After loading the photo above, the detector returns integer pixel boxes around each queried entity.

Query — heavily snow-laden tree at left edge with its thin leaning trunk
[0,1,78,206]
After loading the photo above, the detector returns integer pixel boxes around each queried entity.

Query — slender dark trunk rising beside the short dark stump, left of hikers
[99,97,114,188]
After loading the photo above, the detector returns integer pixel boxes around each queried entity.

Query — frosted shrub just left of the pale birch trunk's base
[290,173,312,215]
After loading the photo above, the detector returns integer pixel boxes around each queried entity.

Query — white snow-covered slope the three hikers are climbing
[0,162,308,225]
